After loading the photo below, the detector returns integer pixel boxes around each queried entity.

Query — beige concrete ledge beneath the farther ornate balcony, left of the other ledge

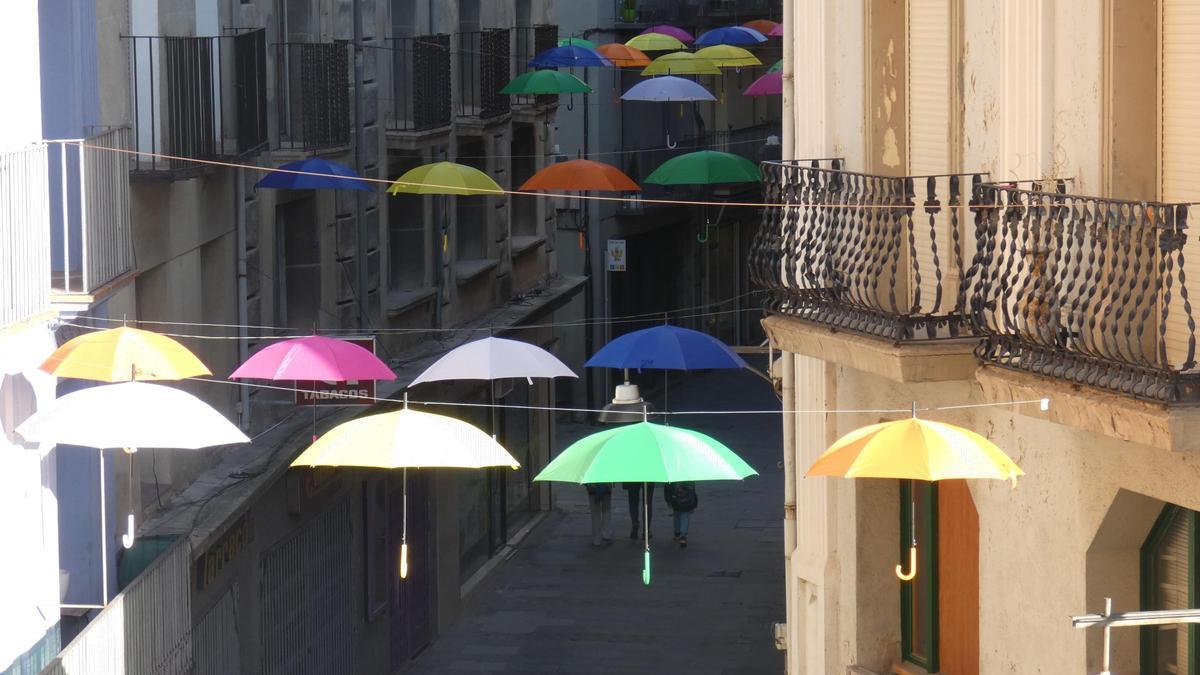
[762,316,979,382]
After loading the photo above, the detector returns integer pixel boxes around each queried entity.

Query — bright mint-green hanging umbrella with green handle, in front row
[534,420,758,585]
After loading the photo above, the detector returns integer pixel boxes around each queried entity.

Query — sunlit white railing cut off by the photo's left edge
[0,143,50,327]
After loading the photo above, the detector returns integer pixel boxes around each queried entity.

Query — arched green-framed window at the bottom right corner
[1141,504,1200,675]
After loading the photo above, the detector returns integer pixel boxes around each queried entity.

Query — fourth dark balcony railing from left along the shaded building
[455,28,512,119]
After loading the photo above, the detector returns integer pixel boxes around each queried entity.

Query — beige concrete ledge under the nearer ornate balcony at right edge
[976,365,1200,452]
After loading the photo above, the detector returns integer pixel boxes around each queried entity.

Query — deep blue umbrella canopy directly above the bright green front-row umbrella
[583,325,746,370]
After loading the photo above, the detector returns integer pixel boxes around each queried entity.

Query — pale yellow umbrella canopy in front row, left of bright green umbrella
[292,408,521,468]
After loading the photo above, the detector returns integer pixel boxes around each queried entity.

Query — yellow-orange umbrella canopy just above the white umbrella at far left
[41,325,212,382]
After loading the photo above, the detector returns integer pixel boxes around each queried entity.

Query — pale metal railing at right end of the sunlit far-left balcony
[47,127,134,293]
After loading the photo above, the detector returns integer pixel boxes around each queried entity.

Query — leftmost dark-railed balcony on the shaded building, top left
[126,29,268,179]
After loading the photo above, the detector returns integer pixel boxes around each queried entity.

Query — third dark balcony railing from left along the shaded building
[388,35,451,131]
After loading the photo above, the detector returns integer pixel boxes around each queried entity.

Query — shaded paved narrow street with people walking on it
[409,359,784,675]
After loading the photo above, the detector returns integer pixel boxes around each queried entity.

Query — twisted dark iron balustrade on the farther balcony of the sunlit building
[750,160,980,341]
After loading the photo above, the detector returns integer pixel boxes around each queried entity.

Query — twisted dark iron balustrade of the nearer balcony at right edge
[964,181,1200,401]
